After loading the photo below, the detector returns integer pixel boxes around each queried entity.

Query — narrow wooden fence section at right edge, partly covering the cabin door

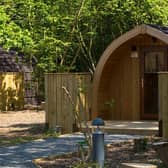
[159,72,168,139]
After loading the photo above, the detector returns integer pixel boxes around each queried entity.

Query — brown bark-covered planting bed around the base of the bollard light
[36,141,166,168]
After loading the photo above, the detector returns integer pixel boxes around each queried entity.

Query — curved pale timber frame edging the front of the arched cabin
[92,25,168,118]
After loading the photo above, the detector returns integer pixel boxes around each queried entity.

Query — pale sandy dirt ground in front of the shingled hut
[0,109,45,146]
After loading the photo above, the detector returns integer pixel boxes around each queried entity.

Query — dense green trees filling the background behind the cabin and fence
[0,0,168,77]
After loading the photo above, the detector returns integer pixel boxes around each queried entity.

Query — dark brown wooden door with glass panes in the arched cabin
[141,47,168,120]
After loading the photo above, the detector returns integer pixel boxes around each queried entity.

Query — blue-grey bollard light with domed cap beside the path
[92,118,105,168]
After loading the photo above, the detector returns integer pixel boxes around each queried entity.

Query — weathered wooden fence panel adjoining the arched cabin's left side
[45,73,91,133]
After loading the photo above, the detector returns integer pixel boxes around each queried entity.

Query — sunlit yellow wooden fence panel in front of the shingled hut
[0,72,24,111]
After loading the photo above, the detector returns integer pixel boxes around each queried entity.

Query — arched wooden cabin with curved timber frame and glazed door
[92,25,168,120]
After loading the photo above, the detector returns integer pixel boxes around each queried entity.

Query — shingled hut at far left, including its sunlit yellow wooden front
[0,47,33,111]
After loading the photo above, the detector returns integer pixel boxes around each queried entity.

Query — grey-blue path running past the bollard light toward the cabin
[0,134,144,168]
